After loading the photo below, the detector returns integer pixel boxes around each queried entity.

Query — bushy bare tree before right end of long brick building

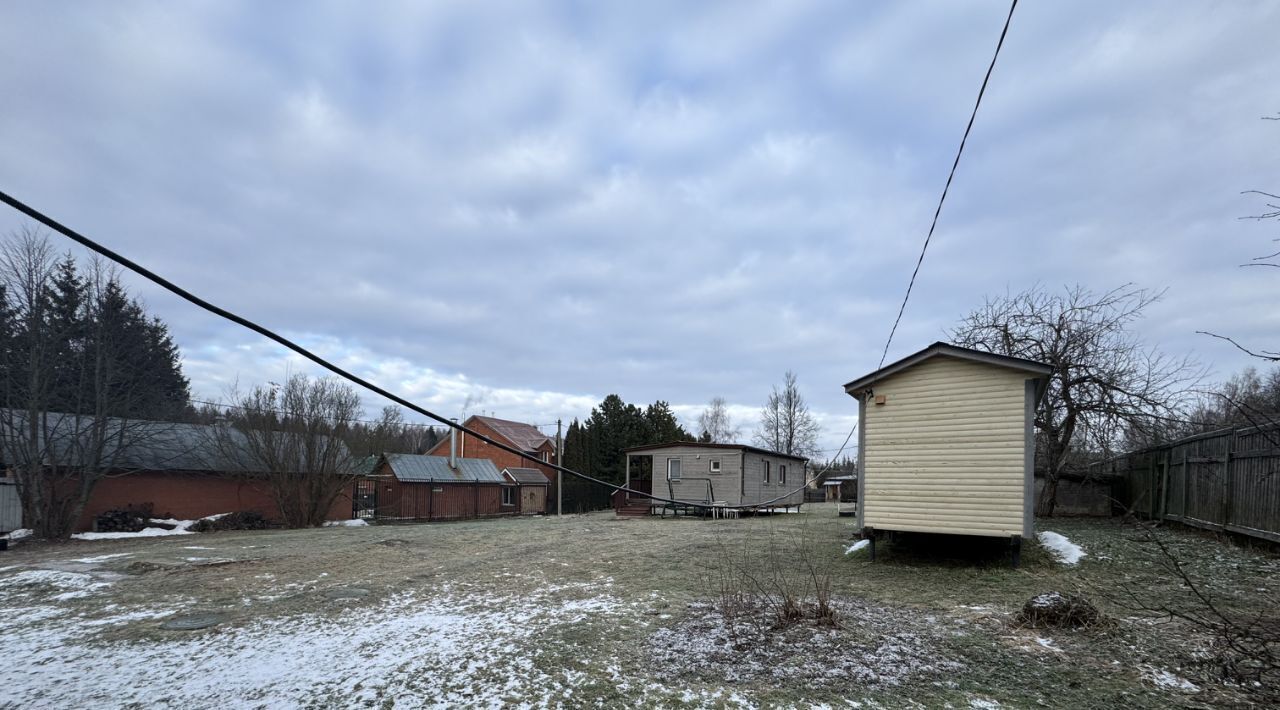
[212,375,362,527]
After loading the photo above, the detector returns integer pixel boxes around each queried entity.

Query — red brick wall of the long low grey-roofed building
[76,472,351,531]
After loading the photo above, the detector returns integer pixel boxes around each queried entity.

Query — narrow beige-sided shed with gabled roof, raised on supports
[845,343,1050,537]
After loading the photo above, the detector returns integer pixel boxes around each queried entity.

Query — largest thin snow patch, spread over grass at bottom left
[0,580,621,707]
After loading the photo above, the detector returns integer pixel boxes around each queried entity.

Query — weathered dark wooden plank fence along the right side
[1091,425,1280,542]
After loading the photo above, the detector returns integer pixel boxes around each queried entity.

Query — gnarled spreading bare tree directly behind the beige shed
[950,285,1203,516]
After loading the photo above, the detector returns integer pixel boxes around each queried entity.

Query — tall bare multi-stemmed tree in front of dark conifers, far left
[0,229,186,539]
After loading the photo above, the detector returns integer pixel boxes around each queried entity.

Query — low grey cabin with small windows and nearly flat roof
[618,441,808,513]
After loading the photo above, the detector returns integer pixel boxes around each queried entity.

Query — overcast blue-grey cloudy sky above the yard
[0,0,1280,448]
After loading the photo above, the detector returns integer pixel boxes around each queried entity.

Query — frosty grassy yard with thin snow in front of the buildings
[0,505,1280,707]
